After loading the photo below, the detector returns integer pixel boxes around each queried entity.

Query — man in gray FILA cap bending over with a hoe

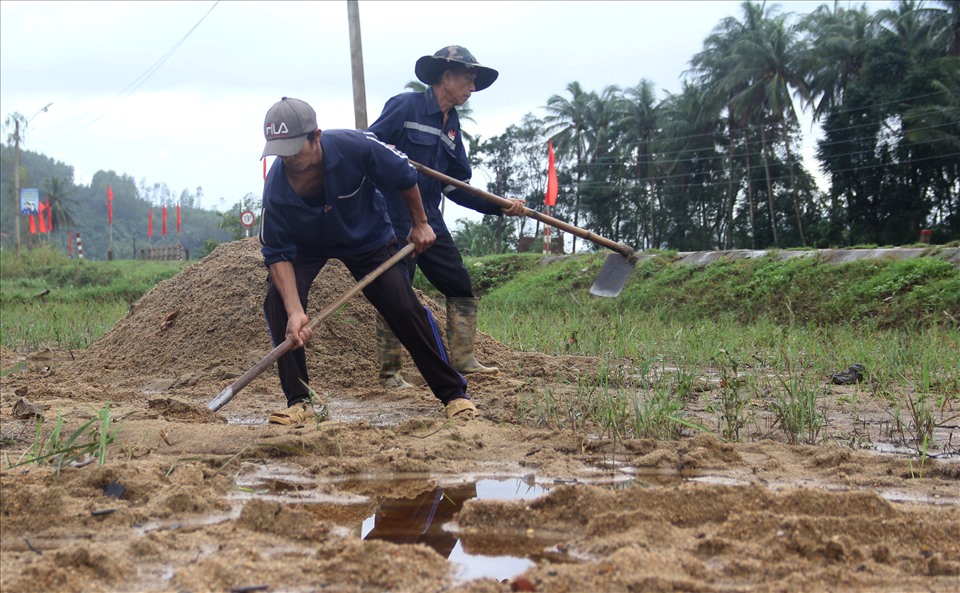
[260,97,476,424]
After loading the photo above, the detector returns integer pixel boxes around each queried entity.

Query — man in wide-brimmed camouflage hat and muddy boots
[367,45,524,389]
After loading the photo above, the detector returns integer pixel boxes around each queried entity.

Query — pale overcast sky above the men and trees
[0,0,891,226]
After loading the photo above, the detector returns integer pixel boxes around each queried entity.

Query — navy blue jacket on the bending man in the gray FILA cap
[260,130,417,267]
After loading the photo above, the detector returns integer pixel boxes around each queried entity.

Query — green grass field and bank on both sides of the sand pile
[0,244,960,446]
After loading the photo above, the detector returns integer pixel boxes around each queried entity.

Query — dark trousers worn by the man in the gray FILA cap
[263,243,467,406]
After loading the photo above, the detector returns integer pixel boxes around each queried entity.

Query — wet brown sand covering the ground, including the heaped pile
[0,239,960,593]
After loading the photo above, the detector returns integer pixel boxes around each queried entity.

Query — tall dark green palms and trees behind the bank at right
[462,0,960,255]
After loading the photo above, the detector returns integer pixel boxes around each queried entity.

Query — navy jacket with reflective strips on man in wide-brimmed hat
[367,87,502,237]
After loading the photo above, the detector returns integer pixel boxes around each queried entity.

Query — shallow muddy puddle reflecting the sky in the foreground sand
[218,462,960,582]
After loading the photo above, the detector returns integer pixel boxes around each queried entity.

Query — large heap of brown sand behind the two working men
[50,238,513,401]
